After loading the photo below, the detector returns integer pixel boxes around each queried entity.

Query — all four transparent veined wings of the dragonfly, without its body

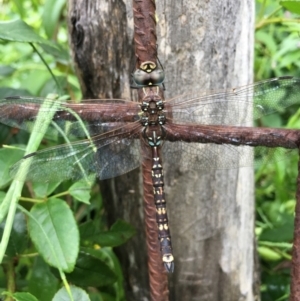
[0,77,300,181]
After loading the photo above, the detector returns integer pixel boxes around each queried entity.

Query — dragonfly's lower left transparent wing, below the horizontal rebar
[11,122,141,182]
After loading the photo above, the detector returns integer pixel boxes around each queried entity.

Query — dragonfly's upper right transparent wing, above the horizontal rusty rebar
[166,77,300,125]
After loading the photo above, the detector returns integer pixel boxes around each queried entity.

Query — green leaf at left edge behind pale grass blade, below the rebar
[0,148,24,188]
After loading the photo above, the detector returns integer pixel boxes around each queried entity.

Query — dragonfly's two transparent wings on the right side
[163,77,300,170]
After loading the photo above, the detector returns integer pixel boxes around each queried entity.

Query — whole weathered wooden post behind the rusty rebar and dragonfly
[69,0,257,301]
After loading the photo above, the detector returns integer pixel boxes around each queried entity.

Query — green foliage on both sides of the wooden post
[0,0,300,301]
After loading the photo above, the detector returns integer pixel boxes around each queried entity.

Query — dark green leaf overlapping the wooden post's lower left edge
[79,220,136,247]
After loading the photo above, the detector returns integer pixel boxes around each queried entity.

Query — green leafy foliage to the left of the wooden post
[0,0,135,301]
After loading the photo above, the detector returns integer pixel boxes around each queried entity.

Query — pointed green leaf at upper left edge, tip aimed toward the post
[0,20,54,47]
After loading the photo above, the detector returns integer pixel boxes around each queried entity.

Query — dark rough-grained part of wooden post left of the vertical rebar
[68,0,150,300]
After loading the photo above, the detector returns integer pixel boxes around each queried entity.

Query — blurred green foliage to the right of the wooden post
[254,0,300,301]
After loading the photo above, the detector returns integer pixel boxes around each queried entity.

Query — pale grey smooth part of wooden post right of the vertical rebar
[157,0,257,301]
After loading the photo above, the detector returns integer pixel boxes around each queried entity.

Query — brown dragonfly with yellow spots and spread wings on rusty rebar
[0,62,300,272]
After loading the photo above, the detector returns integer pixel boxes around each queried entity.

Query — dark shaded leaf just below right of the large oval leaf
[67,248,117,287]
